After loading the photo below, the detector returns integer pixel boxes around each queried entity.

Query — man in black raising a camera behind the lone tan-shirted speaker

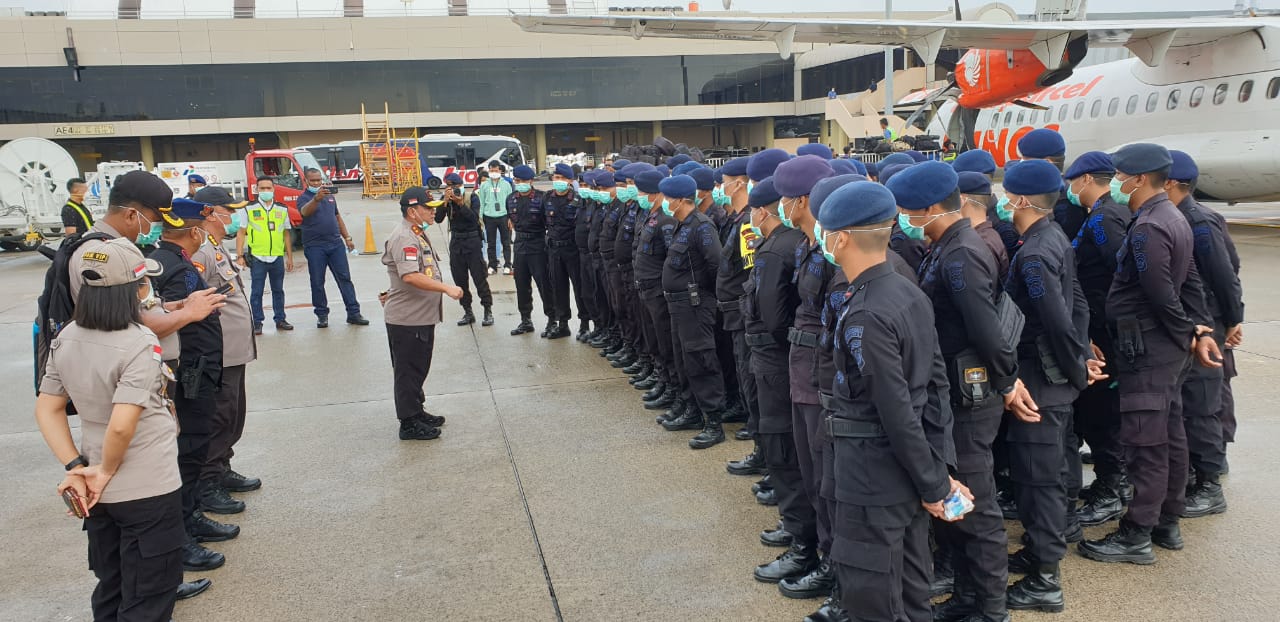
[435,173,488,326]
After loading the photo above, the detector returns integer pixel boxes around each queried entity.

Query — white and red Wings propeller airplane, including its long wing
[512,0,1280,203]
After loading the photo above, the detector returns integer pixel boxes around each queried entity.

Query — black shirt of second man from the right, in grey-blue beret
[1106,192,1213,363]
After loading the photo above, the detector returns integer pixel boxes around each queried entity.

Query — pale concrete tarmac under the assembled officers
[0,193,1280,622]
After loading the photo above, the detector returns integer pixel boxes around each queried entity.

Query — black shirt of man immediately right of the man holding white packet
[919,218,1018,392]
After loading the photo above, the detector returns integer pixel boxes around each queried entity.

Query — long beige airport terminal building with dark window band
[0,0,962,170]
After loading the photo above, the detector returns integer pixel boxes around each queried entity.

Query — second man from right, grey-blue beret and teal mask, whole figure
[1079,143,1222,563]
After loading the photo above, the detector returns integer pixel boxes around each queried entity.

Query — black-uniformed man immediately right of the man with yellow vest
[742,175,829,594]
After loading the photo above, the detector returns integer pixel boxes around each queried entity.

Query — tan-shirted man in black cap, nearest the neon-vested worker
[191,187,262,507]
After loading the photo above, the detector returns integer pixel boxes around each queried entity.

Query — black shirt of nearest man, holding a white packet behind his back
[831,262,955,507]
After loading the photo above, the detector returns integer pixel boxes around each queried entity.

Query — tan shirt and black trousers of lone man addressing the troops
[383,220,443,421]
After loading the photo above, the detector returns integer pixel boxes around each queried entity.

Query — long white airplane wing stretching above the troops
[512,15,1265,68]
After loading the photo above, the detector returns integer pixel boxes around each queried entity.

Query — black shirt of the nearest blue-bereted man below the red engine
[1005,218,1092,406]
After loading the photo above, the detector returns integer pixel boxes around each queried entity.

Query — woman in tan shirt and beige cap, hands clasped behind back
[36,239,194,621]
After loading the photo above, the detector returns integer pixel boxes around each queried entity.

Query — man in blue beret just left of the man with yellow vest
[658,175,724,449]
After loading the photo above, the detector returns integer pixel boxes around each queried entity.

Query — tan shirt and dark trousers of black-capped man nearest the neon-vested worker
[191,232,257,481]
